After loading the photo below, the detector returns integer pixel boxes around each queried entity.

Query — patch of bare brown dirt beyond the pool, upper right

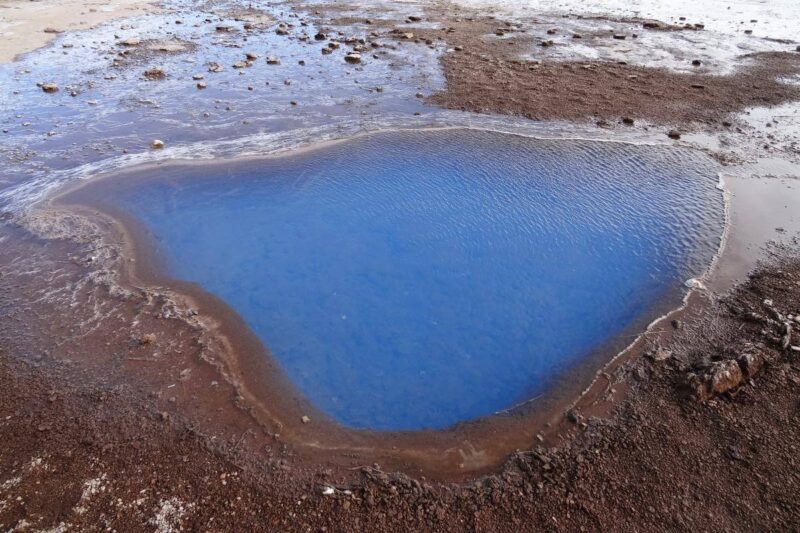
[412,13,800,125]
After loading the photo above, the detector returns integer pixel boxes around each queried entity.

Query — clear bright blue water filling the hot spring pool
[106,130,723,430]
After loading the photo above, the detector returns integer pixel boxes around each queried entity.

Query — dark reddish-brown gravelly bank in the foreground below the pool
[0,243,800,531]
